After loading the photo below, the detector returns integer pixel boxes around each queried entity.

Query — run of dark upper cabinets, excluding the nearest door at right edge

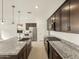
[48,0,70,32]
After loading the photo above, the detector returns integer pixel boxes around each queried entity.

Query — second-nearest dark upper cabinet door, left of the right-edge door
[61,1,70,32]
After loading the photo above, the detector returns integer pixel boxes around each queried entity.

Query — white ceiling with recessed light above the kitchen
[0,0,65,20]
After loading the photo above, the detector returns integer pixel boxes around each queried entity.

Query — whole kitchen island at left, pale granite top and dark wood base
[0,37,31,59]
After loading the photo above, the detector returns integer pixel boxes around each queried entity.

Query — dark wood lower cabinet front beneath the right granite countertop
[48,44,62,59]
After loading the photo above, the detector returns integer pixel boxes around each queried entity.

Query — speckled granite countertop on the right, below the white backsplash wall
[49,41,79,59]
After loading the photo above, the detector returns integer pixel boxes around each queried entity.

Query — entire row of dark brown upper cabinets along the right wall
[48,0,79,33]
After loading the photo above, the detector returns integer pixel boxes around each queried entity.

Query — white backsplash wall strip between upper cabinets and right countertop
[50,31,79,45]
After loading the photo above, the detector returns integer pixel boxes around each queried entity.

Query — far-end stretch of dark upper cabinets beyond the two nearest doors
[47,10,61,31]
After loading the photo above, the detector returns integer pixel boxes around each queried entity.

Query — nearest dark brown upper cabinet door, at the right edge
[70,0,79,33]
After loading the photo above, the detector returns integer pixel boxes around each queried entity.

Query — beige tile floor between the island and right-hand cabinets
[28,42,48,59]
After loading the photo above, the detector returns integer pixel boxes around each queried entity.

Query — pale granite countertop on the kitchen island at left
[0,37,30,56]
